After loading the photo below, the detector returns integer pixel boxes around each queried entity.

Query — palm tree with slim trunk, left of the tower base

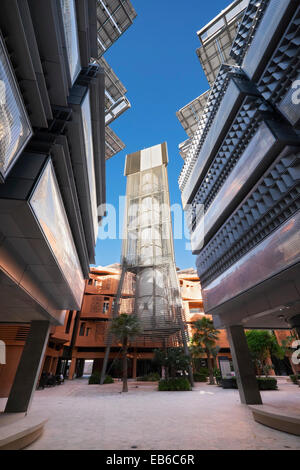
[110,313,142,392]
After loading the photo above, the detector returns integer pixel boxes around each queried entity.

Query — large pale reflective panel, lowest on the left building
[29,161,84,305]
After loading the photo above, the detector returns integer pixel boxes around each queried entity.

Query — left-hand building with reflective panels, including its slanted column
[0,0,136,412]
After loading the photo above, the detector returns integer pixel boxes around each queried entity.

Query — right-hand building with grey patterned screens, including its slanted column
[179,0,300,403]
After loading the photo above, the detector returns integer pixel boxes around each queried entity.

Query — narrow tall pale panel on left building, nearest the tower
[82,91,98,241]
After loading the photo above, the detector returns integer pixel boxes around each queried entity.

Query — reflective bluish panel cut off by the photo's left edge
[0,38,32,178]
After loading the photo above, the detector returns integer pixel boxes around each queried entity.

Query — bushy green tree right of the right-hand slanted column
[246,330,286,376]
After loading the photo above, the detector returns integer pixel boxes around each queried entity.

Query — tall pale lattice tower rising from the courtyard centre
[122,143,186,346]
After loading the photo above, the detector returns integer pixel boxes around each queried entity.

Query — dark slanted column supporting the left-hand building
[5,321,50,413]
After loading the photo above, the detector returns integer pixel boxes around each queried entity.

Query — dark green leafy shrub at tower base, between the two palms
[153,348,190,378]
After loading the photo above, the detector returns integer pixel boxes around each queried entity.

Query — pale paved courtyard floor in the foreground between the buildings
[0,379,300,450]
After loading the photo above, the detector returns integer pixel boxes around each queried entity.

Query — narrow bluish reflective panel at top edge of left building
[60,0,81,84]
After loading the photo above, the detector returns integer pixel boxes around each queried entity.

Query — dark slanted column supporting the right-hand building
[227,325,262,405]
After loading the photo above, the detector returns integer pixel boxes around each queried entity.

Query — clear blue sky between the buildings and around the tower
[96,0,230,269]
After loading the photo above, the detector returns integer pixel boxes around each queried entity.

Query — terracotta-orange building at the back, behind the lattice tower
[51,265,231,379]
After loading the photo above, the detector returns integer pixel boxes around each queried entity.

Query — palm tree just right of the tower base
[191,317,220,385]
